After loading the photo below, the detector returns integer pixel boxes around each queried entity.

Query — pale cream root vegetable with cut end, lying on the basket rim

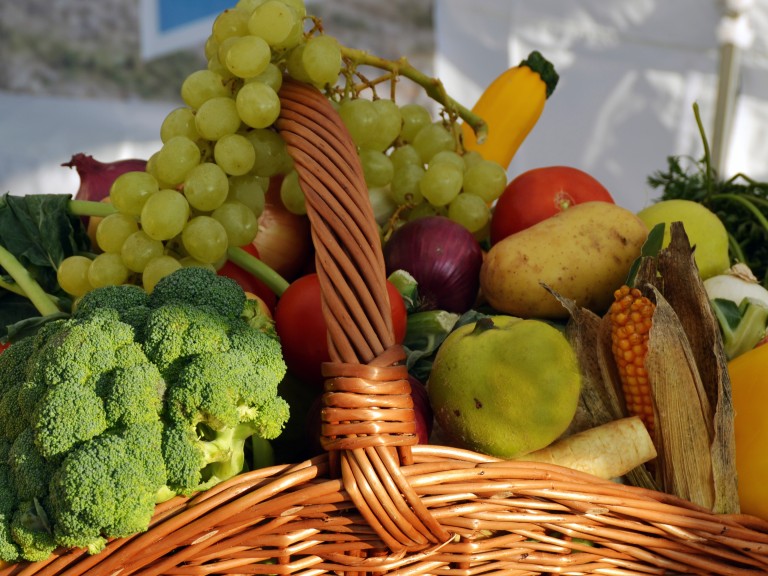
[518,416,656,480]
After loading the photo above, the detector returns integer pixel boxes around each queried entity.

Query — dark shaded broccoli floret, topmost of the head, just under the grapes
[149,266,246,319]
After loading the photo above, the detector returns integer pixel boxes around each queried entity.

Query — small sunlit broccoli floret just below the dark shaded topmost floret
[143,304,229,380]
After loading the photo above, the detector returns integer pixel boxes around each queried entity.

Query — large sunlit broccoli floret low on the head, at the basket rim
[50,421,166,553]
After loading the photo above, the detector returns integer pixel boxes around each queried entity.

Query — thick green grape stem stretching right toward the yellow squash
[341,46,488,142]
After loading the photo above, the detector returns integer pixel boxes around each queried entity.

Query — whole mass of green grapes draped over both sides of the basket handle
[59,0,496,296]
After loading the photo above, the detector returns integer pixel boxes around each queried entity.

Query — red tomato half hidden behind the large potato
[491,166,614,244]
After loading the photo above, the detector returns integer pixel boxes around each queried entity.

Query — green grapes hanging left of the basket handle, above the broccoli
[59,0,341,296]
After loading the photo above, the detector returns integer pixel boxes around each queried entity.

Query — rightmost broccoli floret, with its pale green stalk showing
[163,350,288,494]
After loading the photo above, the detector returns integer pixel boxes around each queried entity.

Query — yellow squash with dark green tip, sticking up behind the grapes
[462,51,559,169]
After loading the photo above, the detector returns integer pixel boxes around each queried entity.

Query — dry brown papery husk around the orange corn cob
[561,223,739,513]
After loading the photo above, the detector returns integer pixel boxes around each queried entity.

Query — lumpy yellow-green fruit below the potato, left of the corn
[427,316,581,458]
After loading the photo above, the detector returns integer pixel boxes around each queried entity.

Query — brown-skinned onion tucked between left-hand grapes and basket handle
[253,177,314,281]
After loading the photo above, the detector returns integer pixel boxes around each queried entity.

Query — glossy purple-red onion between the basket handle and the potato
[384,216,483,314]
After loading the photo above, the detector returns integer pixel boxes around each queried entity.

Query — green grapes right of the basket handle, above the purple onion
[339,98,507,237]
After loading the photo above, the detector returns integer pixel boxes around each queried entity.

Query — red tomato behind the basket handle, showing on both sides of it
[275,273,407,386]
